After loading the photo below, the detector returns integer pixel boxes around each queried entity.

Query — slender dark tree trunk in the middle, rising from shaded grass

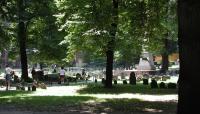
[105,0,119,88]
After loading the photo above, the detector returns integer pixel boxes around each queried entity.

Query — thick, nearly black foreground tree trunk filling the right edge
[177,0,200,114]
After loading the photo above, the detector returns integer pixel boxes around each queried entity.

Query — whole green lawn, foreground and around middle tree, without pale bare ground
[0,84,177,114]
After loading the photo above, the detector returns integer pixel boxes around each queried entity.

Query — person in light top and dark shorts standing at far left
[5,65,12,90]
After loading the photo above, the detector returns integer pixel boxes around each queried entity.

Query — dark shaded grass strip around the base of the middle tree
[78,84,177,95]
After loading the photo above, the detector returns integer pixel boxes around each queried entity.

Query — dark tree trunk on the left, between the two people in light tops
[18,0,28,81]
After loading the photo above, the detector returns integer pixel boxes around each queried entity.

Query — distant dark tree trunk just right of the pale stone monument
[161,35,169,73]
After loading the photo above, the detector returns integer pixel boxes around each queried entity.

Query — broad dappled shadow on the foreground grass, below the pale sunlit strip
[0,96,177,114]
